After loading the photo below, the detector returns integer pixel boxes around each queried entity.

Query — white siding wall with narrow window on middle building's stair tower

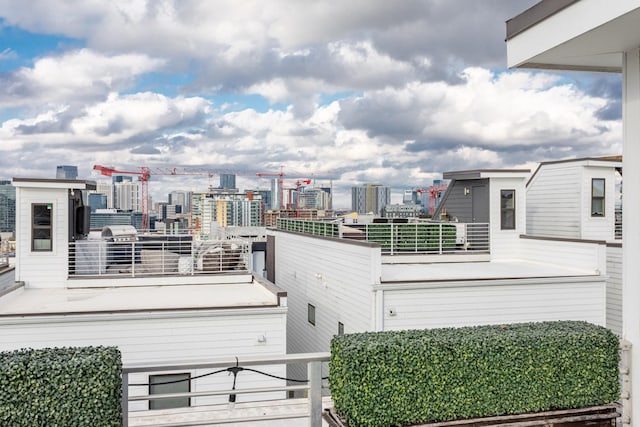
[489,178,526,259]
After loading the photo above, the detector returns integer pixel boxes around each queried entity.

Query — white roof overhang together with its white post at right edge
[506,0,640,425]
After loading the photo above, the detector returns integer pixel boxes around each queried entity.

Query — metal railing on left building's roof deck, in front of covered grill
[69,238,251,278]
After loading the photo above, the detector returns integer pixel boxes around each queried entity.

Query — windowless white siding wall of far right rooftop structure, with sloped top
[527,163,582,239]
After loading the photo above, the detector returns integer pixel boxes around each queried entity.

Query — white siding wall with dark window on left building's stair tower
[16,188,69,288]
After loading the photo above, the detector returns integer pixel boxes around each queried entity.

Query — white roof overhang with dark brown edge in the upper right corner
[506,0,640,72]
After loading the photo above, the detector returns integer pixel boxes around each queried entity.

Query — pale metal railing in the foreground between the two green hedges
[122,353,330,427]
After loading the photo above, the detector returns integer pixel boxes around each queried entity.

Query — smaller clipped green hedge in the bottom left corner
[0,347,122,427]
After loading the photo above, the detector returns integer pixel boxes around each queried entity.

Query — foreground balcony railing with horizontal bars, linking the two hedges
[122,353,330,427]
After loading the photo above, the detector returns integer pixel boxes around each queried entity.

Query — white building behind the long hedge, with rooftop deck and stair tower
[267,164,619,388]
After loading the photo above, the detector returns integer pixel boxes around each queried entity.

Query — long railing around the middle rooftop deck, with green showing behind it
[277,219,490,255]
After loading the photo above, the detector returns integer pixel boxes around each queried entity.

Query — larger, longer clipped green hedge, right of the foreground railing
[329,321,620,427]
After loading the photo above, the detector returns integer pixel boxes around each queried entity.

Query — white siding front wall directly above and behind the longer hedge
[384,278,605,330]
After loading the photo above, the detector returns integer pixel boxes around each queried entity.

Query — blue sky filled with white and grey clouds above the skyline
[0,0,622,208]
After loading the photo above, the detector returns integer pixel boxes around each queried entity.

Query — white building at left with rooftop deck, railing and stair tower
[0,178,287,425]
